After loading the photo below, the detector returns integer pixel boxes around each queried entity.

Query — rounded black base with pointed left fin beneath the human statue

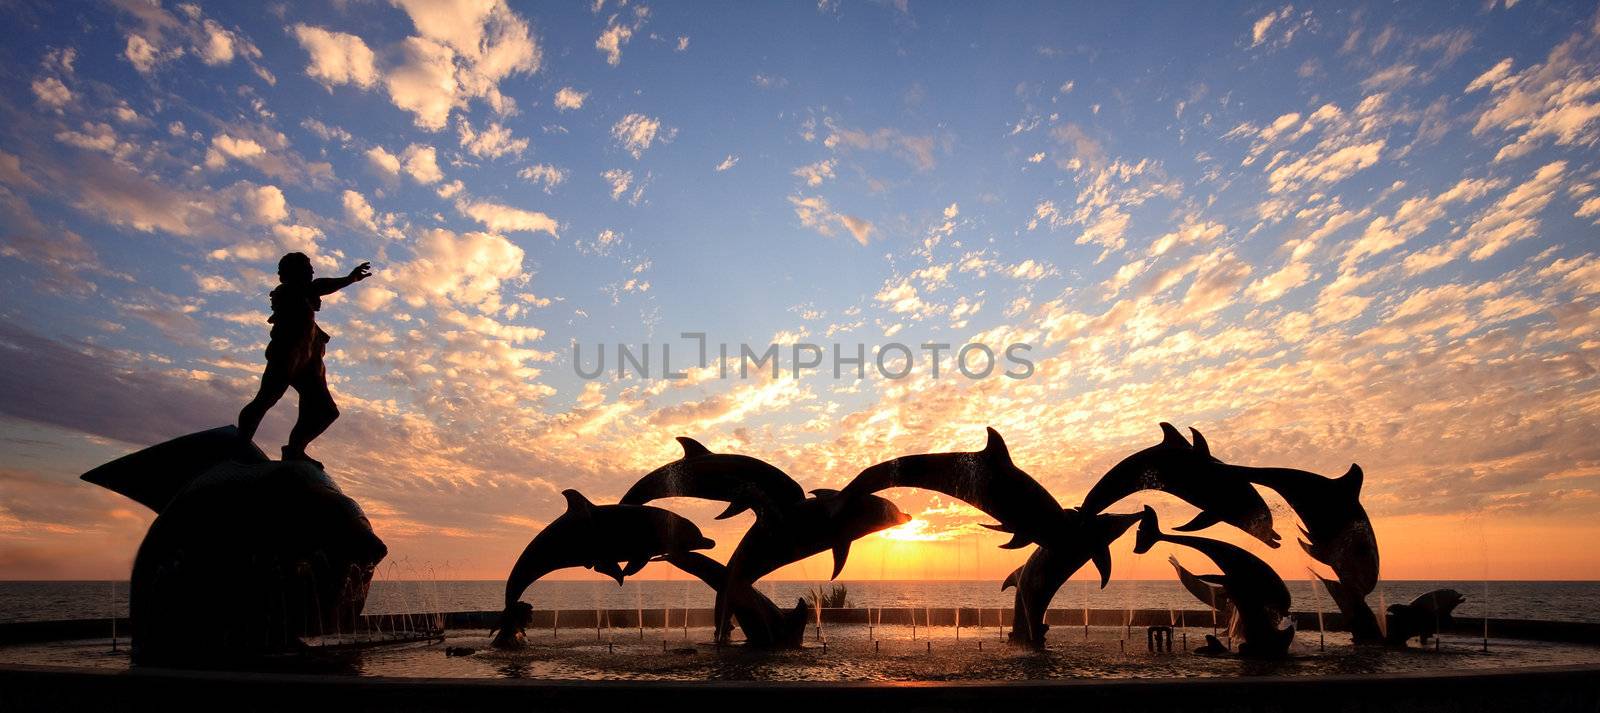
[83,427,387,667]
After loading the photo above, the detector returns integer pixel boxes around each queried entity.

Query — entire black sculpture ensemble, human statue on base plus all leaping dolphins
[83,253,1440,663]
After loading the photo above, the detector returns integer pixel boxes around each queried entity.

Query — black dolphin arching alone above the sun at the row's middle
[843,428,1064,550]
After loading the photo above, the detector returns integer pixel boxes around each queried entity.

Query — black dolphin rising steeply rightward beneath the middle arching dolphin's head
[1000,510,1141,646]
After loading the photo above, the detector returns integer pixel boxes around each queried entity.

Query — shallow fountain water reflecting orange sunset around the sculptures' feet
[0,623,1600,681]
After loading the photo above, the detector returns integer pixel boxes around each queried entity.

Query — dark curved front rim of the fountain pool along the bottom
[0,665,1600,713]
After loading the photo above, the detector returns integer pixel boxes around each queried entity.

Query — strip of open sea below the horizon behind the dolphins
[0,579,1600,623]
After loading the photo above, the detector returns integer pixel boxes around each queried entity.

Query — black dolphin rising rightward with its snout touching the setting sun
[715,489,910,641]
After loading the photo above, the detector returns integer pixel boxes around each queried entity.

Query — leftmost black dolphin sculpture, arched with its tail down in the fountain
[494,489,715,649]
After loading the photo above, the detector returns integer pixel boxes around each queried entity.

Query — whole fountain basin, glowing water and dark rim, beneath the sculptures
[0,609,1600,713]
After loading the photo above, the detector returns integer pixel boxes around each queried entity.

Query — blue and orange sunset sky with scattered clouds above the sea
[0,0,1600,579]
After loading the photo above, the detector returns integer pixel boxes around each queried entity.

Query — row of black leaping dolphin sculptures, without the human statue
[480,424,1461,659]
